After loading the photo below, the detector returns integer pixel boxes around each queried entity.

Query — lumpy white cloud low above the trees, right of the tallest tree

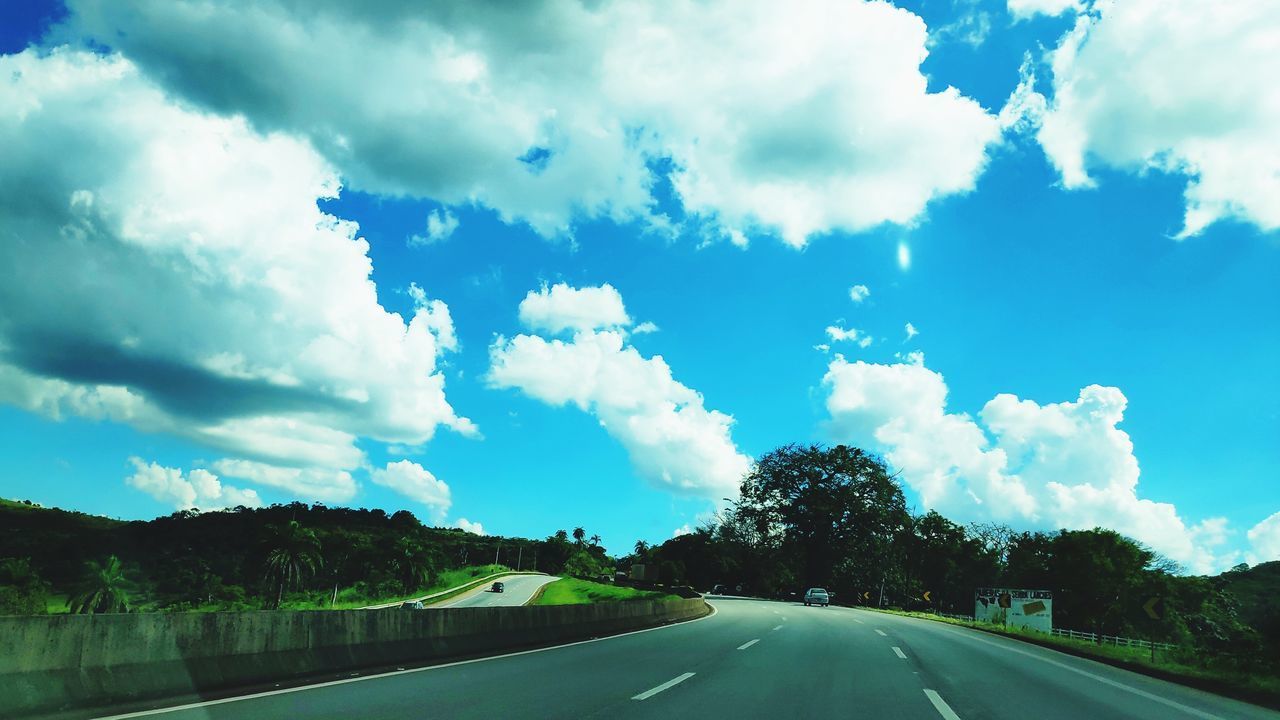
[823,354,1231,571]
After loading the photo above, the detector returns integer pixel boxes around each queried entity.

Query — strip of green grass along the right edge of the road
[865,607,1280,707]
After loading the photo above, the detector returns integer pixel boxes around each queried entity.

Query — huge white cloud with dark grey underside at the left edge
[0,49,474,497]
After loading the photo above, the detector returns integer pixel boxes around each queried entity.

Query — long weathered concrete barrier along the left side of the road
[0,598,709,717]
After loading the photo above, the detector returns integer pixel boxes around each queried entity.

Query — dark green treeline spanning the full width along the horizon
[0,445,1280,669]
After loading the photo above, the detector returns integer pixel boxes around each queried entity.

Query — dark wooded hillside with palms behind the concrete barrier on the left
[0,500,613,615]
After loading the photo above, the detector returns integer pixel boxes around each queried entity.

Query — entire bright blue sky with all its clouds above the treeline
[0,0,1280,573]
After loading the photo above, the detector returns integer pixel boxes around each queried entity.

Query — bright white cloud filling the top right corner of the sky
[1037,0,1280,237]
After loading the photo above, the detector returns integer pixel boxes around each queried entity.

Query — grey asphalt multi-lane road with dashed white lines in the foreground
[94,600,1280,720]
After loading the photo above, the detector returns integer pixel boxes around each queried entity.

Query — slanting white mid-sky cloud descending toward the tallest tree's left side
[489,286,751,500]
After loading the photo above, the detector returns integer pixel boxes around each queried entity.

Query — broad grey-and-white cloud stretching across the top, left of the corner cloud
[60,0,1000,246]
